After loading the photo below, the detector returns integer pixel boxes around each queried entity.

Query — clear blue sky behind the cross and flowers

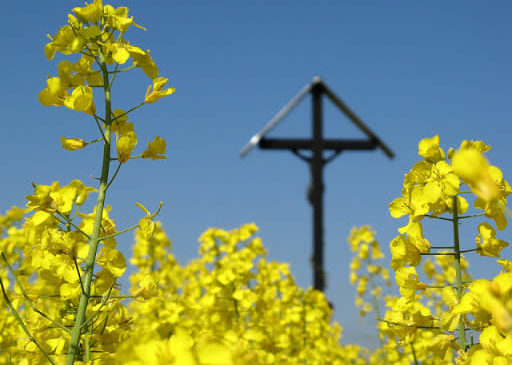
[0,0,512,343]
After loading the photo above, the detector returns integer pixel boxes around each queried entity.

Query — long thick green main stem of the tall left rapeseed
[66,54,112,365]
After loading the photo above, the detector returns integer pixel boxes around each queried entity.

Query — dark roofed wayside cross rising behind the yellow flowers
[240,77,394,291]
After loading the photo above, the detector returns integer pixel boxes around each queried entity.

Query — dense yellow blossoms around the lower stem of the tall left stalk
[0,185,128,364]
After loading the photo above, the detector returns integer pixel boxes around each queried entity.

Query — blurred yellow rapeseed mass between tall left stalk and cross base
[120,224,363,365]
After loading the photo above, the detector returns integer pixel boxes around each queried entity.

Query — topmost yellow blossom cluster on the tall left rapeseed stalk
[39,0,175,163]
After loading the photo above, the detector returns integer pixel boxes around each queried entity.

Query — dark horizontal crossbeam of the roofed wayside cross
[259,138,379,151]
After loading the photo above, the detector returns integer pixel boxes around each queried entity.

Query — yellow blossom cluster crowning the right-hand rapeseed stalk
[389,136,512,270]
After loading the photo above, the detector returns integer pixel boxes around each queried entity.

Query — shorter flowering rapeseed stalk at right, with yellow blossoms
[384,136,512,364]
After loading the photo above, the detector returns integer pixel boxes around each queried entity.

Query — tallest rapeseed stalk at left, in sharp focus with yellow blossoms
[33,0,175,365]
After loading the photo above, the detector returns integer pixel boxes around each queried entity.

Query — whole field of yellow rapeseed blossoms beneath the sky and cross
[0,0,512,365]
